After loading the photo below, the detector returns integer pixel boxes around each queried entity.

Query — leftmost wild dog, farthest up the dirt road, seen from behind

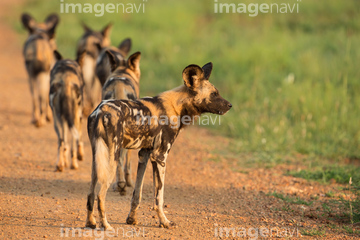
[21,13,59,127]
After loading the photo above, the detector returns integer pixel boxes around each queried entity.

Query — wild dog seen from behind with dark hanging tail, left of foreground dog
[50,51,85,172]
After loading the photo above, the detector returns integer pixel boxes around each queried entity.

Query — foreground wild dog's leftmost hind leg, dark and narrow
[85,156,97,229]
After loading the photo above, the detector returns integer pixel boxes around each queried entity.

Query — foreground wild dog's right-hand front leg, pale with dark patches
[151,157,175,228]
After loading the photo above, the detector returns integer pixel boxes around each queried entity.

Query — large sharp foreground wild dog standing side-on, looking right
[86,63,232,230]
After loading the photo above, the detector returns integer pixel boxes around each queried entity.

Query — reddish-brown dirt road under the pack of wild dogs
[0,1,351,239]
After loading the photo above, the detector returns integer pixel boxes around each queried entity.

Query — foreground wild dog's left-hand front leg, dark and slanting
[126,149,150,225]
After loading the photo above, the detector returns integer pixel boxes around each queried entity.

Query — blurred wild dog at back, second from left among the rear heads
[77,23,112,115]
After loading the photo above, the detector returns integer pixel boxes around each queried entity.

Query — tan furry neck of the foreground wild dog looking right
[159,85,201,125]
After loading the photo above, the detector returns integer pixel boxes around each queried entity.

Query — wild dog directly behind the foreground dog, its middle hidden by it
[102,51,141,195]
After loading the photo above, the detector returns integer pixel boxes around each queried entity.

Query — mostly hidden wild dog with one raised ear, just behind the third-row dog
[95,38,131,86]
